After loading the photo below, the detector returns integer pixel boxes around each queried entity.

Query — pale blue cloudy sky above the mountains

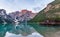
[0,0,54,13]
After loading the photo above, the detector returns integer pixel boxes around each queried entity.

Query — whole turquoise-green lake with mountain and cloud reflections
[0,23,60,37]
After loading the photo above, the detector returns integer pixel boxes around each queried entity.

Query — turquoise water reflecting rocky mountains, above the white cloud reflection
[0,23,35,37]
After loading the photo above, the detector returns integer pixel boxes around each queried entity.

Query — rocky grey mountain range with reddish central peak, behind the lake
[0,9,36,24]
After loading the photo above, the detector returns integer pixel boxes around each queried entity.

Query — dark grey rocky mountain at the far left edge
[0,9,13,23]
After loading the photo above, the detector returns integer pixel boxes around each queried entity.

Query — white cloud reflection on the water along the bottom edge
[5,32,44,37]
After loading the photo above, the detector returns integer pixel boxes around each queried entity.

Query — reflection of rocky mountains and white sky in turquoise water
[0,23,43,37]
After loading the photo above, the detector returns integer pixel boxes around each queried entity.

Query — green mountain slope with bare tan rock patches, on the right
[30,0,60,22]
